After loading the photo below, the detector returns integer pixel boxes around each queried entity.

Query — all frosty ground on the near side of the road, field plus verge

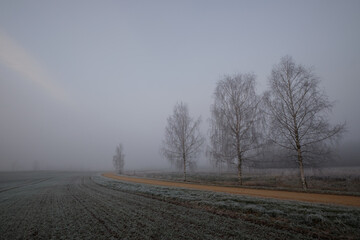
[0,172,360,239]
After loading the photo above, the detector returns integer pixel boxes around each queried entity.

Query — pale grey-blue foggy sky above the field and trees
[0,0,360,170]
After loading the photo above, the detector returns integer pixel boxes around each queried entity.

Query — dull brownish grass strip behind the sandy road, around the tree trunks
[128,167,360,195]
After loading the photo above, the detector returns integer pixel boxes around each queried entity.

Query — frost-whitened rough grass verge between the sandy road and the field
[93,176,360,239]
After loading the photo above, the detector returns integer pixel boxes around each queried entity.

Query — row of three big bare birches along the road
[161,56,345,190]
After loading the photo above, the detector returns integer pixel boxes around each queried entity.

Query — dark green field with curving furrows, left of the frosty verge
[0,173,358,239]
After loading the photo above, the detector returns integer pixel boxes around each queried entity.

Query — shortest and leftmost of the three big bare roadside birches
[161,103,204,181]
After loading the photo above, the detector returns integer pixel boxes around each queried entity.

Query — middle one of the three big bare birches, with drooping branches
[210,74,260,184]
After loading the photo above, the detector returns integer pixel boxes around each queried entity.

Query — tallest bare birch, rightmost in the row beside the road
[264,56,345,190]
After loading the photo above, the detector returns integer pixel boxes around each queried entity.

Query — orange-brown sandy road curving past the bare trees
[103,173,360,207]
